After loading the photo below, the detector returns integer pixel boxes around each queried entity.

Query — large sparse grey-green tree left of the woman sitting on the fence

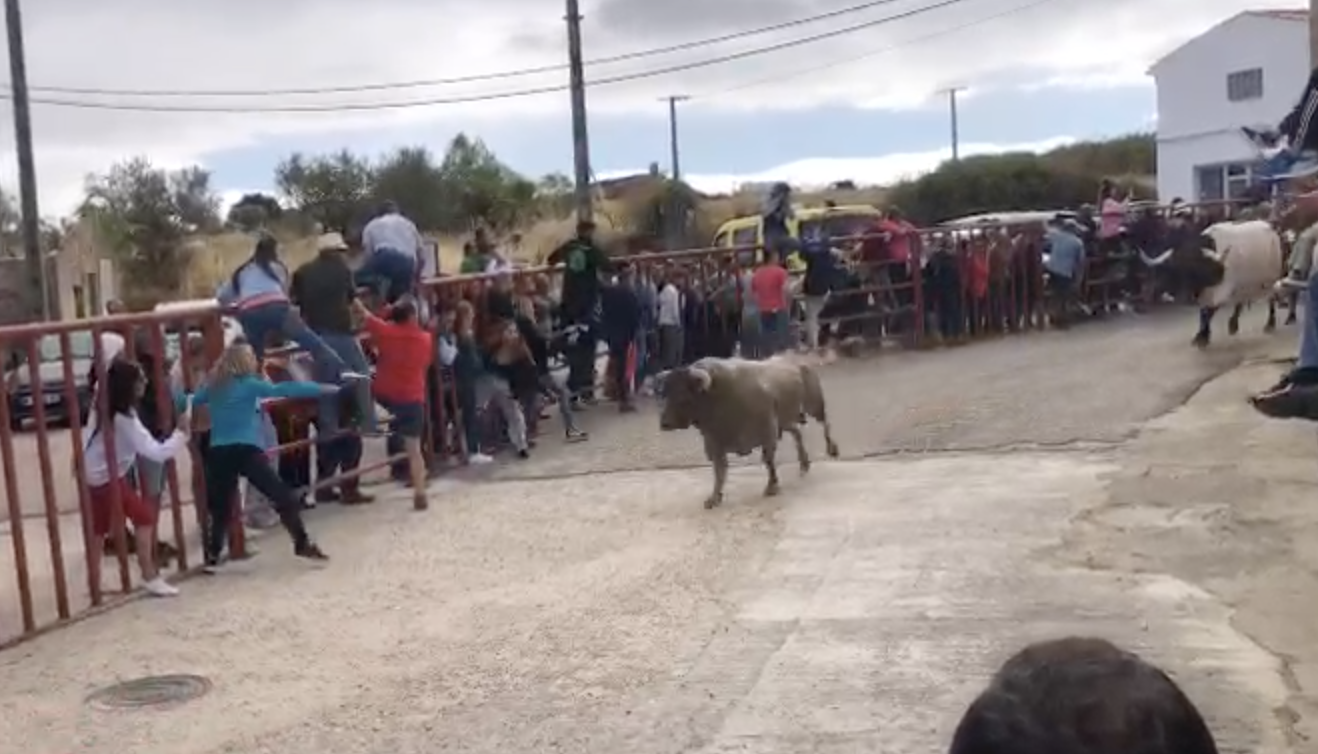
[79,157,219,294]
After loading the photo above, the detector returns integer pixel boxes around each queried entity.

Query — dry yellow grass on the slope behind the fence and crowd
[180,189,884,299]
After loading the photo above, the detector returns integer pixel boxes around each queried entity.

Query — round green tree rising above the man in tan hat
[274,149,374,233]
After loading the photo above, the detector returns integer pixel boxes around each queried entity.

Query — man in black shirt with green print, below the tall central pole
[548,220,613,401]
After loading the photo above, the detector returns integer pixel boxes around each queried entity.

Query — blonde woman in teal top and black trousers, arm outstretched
[192,343,340,573]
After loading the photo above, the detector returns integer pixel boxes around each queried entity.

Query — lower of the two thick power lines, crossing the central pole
[0,0,967,115]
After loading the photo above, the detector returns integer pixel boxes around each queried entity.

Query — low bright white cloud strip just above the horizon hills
[600,136,1075,194]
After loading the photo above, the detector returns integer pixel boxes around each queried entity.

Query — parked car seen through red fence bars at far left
[4,331,95,431]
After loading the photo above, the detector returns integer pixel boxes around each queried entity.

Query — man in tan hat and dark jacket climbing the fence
[289,233,376,502]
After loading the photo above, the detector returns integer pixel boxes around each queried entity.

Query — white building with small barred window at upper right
[1149,11,1309,202]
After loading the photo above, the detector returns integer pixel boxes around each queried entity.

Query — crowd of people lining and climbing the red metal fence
[69,186,1275,595]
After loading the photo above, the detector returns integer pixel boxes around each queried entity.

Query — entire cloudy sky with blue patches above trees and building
[0,0,1300,215]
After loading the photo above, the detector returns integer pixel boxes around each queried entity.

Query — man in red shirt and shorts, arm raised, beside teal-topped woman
[353,297,435,510]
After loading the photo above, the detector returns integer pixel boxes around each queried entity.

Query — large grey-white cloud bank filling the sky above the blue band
[0,0,1296,214]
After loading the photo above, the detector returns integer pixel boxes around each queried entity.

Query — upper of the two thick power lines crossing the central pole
[15,0,927,98]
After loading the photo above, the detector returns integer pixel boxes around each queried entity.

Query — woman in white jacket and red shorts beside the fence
[83,359,190,597]
